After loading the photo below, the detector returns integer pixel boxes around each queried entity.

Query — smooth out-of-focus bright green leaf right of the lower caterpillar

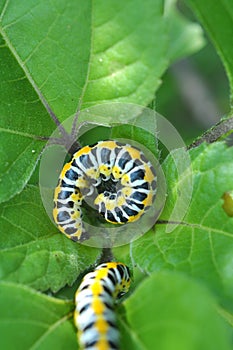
[121,272,231,350]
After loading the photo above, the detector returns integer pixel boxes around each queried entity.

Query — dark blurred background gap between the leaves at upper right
[155,1,229,144]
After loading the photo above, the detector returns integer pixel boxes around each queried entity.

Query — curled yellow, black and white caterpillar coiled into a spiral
[53,140,156,241]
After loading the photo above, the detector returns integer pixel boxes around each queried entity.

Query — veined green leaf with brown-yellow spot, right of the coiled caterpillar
[131,143,233,301]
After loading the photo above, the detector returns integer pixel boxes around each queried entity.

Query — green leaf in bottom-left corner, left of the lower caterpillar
[0,282,77,350]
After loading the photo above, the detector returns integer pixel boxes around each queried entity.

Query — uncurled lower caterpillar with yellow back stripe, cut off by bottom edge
[74,262,130,350]
